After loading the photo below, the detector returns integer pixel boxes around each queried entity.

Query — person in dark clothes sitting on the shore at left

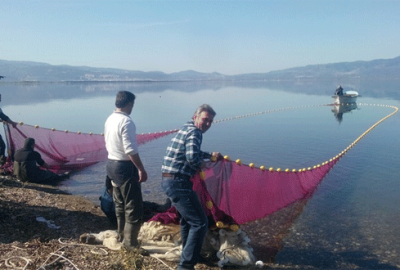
[14,138,66,183]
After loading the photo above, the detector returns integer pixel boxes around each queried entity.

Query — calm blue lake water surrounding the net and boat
[0,83,400,269]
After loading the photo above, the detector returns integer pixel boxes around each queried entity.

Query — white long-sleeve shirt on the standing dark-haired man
[104,112,139,160]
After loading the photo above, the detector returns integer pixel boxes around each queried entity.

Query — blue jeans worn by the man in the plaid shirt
[161,177,208,269]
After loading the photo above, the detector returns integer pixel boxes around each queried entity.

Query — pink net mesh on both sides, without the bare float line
[5,122,338,228]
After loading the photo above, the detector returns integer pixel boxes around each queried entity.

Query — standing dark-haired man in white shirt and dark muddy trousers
[104,91,147,255]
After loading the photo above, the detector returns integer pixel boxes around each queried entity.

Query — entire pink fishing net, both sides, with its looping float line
[2,104,398,225]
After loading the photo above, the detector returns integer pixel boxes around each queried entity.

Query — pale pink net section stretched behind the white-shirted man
[5,125,176,173]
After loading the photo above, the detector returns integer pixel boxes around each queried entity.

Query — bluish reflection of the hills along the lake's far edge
[0,79,400,105]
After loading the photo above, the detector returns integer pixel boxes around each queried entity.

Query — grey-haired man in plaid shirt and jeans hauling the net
[161,104,222,270]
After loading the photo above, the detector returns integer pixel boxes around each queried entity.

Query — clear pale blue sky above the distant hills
[0,0,400,75]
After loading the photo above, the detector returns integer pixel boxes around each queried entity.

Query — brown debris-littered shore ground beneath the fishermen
[0,176,300,270]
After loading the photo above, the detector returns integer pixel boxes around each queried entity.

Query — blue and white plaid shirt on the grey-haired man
[161,121,211,177]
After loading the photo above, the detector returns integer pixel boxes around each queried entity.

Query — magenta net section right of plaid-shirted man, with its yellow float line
[184,104,398,225]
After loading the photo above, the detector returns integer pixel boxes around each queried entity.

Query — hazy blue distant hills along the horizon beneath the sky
[0,56,400,82]
